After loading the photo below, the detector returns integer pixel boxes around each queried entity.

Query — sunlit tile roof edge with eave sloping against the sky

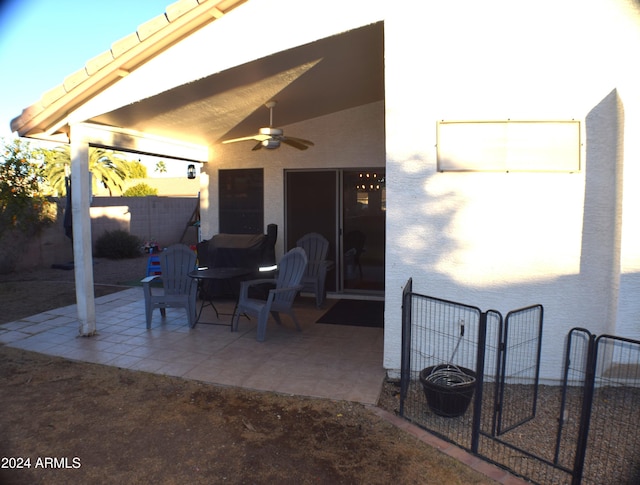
[11,0,247,138]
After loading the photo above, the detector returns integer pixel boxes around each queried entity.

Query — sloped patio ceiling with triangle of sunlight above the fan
[89,23,384,145]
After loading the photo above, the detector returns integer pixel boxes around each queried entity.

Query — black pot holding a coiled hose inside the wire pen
[420,364,476,418]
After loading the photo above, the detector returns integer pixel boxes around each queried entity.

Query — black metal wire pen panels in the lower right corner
[558,328,640,484]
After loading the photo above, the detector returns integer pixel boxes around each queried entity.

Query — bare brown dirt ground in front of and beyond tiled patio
[0,258,495,484]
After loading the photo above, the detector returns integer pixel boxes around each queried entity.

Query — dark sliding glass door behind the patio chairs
[285,169,386,293]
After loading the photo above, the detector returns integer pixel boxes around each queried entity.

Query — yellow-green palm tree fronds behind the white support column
[41,145,129,196]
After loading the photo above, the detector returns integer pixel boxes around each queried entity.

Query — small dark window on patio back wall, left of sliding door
[218,168,264,234]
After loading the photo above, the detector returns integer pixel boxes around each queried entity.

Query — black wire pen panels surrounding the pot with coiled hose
[400,280,596,484]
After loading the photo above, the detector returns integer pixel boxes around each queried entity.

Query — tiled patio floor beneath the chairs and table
[0,288,385,404]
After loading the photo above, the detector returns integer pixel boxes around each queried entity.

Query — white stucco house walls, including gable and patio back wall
[56,0,640,380]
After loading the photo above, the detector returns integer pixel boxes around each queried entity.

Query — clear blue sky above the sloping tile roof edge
[0,0,170,138]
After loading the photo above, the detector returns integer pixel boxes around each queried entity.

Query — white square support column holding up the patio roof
[69,126,96,337]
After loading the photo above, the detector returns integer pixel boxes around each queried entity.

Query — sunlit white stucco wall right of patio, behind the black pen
[384,1,640,379]
